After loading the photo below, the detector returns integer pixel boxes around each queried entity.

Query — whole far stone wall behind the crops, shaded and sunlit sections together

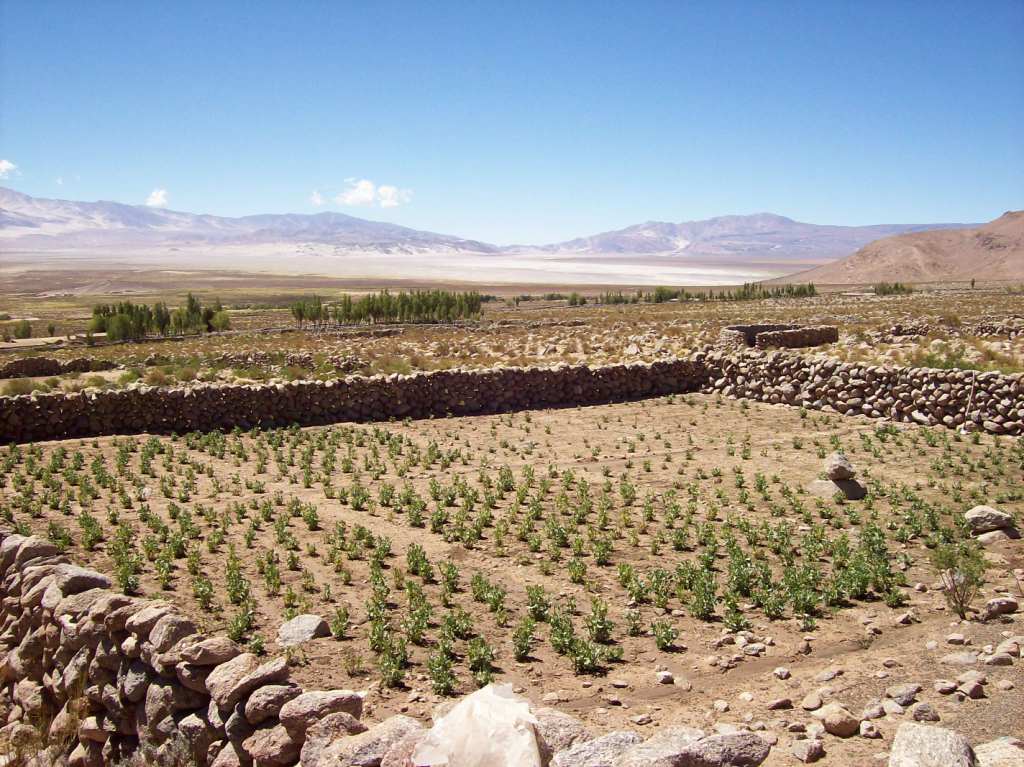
[0,350,1024,442]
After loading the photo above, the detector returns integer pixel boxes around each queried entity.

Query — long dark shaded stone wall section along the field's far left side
[0,359,707,442]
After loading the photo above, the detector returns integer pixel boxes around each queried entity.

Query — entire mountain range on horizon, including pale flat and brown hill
[6,187,1024,285]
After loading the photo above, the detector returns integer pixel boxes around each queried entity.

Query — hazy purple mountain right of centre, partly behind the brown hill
[520,213,971,263]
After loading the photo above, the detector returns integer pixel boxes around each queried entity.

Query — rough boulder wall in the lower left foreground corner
[0,530,389,767]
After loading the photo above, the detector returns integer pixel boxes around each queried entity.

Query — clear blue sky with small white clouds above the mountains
[0,0,1024,244]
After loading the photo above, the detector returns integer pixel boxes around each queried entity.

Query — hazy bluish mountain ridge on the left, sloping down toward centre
[0,187,498,253]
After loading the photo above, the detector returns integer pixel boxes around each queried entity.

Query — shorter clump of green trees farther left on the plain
[87,293,231,341]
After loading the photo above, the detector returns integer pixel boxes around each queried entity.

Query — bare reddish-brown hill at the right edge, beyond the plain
[786,211,1024,285]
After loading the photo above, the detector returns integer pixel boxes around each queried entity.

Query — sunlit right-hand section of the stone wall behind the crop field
[697,352,1024,434]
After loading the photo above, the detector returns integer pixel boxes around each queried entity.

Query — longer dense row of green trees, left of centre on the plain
[289,290,484,328]
